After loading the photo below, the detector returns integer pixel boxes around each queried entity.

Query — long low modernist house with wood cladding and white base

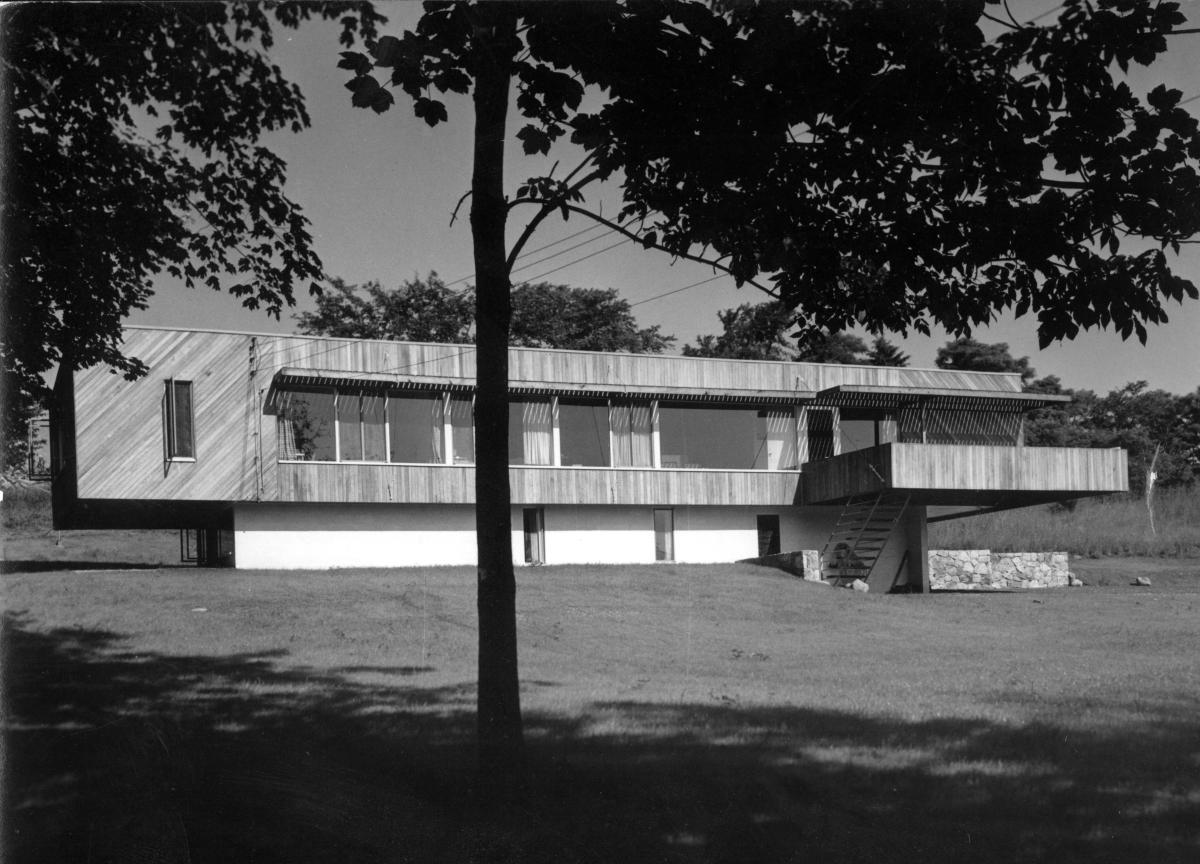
[52,328,1127,590]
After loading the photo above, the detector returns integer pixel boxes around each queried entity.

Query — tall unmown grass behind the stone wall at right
[929,488,1200,558]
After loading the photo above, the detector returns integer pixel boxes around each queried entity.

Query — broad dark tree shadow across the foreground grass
[4,617,1200,864]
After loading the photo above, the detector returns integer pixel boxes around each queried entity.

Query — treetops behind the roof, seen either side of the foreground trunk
[295,272,674,354]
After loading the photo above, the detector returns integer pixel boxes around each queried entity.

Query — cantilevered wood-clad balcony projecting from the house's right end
[800,443,1129,506]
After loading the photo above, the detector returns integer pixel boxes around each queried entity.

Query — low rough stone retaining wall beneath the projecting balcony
[929,550,1070,590]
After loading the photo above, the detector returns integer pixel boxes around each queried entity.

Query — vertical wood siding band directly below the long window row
[278,462,799,506]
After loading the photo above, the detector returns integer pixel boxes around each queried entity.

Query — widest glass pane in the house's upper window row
[659,406,761,469]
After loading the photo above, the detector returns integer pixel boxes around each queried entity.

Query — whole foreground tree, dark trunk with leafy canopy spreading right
[341,0,1200,780]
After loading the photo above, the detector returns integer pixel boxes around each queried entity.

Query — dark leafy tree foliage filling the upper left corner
[0,1,383,465]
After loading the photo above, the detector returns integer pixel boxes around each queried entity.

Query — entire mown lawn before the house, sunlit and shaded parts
[4,562,1200,864]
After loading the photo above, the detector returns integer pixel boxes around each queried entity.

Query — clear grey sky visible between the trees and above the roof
[130,0,1200,394]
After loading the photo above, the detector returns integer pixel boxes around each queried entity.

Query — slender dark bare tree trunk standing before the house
[470,5,524,791]
